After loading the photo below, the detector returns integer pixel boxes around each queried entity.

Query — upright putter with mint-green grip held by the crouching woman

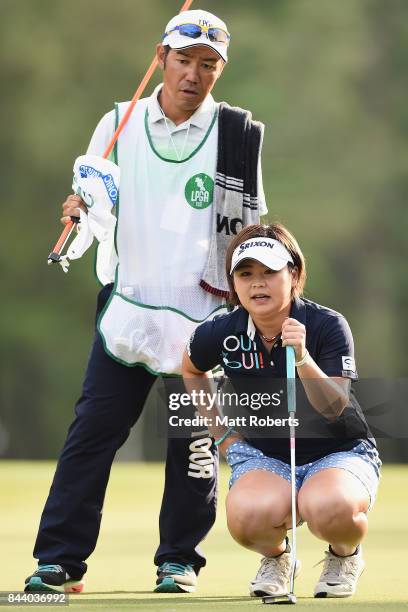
[262,346,297,604]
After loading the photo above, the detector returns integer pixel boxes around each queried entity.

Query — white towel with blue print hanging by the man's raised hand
[60,155,120,284]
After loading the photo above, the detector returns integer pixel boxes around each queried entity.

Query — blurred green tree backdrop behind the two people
[0,0,408,460]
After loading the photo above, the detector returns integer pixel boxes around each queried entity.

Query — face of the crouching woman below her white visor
[233,259,297,317]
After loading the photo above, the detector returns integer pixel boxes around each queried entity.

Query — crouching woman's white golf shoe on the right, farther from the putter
[314,546,365,597]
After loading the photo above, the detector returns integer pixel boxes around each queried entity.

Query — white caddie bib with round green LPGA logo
[99,100,226,374]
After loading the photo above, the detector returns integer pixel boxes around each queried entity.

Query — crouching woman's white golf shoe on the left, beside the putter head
[249,552,300,597]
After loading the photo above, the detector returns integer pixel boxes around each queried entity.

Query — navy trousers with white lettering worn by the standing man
[34,286,218,579]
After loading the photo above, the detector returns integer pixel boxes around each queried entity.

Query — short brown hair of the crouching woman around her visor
[225,223,306,306]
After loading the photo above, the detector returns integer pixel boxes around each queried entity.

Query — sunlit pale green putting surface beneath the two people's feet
[0,461,408,612]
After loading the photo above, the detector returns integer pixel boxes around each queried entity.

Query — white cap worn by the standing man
[162,10,228,62]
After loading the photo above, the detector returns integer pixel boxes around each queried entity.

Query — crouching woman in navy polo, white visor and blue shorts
[183,224,381,597]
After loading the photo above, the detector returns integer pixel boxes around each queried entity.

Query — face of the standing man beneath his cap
[157,45,224,112]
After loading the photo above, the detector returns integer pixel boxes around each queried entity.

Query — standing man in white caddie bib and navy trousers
[25,10,267,592]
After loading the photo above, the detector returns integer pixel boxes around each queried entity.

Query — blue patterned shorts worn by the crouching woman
[227,441,381,510]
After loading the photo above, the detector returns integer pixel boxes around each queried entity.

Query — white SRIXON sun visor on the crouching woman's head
[230,237,293,274]
